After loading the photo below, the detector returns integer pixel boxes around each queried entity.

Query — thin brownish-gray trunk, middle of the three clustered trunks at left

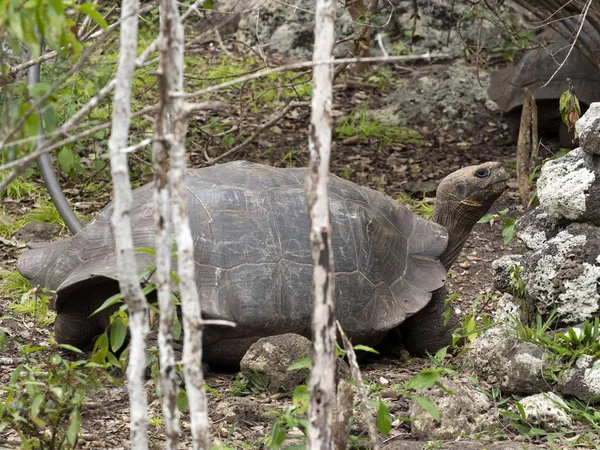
[153,0,179,450]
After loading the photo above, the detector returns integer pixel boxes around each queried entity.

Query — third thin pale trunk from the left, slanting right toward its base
[162,0,210,449]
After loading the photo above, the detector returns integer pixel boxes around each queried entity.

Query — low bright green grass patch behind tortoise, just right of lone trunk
[336,105,421,145]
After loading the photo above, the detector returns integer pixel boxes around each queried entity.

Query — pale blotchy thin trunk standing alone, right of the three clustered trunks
[307,0,336,450]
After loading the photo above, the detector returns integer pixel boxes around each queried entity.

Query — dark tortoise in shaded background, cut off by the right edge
[488,26,600,148]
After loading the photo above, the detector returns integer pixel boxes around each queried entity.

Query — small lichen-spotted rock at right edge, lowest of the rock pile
[557,355,600,402]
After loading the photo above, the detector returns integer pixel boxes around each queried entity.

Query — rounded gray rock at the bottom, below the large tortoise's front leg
[410,379,497,439]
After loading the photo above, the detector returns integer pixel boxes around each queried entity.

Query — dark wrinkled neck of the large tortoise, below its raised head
[431,198,478,271]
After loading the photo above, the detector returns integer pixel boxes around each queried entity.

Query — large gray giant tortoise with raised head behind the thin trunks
[17,162,506,365]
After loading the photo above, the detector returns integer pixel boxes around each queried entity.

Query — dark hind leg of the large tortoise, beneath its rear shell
[54,278,119,350]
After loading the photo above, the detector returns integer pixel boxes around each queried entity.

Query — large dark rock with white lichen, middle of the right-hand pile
[522,223,600,325]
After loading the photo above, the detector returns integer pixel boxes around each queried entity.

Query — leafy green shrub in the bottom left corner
[0,344,115,449]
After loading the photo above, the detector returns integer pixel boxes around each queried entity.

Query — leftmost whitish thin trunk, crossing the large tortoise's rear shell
[108,0,149,450]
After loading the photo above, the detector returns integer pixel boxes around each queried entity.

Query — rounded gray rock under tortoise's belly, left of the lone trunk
[240,333,311,393]
